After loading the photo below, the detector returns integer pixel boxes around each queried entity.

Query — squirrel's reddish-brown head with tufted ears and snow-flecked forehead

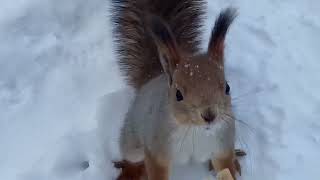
[150,8,236,125]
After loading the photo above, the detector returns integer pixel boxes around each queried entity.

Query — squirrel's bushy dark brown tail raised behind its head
[112,0,205,89]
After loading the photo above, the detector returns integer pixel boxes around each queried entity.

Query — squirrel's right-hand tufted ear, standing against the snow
[208,7,237,60]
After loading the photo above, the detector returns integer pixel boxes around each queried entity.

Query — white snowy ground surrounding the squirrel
[0,0,320,180]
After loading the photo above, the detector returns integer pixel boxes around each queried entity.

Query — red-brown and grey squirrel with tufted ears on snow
[112,0,244,180]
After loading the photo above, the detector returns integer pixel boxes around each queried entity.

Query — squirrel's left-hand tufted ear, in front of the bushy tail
[148,16,181,84]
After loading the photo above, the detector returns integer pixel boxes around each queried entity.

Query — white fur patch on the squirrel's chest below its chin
[170,126,219,164]
